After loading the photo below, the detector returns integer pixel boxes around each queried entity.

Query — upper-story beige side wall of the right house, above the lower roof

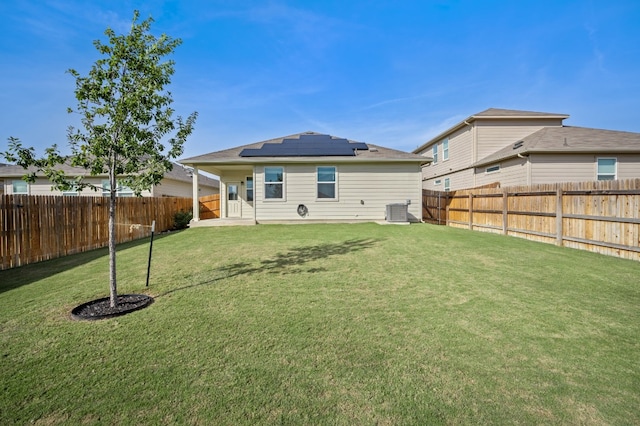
[472,119,562,162]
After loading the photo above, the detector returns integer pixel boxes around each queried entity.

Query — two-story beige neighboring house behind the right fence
[413,108,640,191]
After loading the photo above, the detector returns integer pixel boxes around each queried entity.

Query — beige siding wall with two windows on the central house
[256,163,422,221]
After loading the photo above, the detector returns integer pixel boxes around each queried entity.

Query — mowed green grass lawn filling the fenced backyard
[0,224,640,425]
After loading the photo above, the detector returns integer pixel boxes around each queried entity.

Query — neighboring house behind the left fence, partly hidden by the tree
[0,163,220,198]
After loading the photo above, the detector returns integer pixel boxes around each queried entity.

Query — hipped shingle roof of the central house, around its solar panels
[180,132,430,166]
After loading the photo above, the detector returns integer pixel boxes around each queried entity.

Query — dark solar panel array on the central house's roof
[240,135,369,157]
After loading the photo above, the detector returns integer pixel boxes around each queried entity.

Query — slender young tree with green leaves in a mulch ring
[5,11,197,307]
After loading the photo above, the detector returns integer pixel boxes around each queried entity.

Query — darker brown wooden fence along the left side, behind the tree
[0,195,193,269]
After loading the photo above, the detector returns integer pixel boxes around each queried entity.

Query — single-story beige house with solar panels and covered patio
[180,132,430,223]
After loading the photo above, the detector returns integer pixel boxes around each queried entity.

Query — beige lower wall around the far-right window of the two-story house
[530,154,640,184]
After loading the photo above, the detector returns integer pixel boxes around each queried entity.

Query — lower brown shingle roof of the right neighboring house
[473,126,640,167]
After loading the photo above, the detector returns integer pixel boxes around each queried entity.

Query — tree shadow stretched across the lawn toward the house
[159,238,381,296]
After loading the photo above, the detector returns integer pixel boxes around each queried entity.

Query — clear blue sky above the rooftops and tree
[0,0,640,157]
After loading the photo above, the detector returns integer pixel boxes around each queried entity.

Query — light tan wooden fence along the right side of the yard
[423,179,640,260]
